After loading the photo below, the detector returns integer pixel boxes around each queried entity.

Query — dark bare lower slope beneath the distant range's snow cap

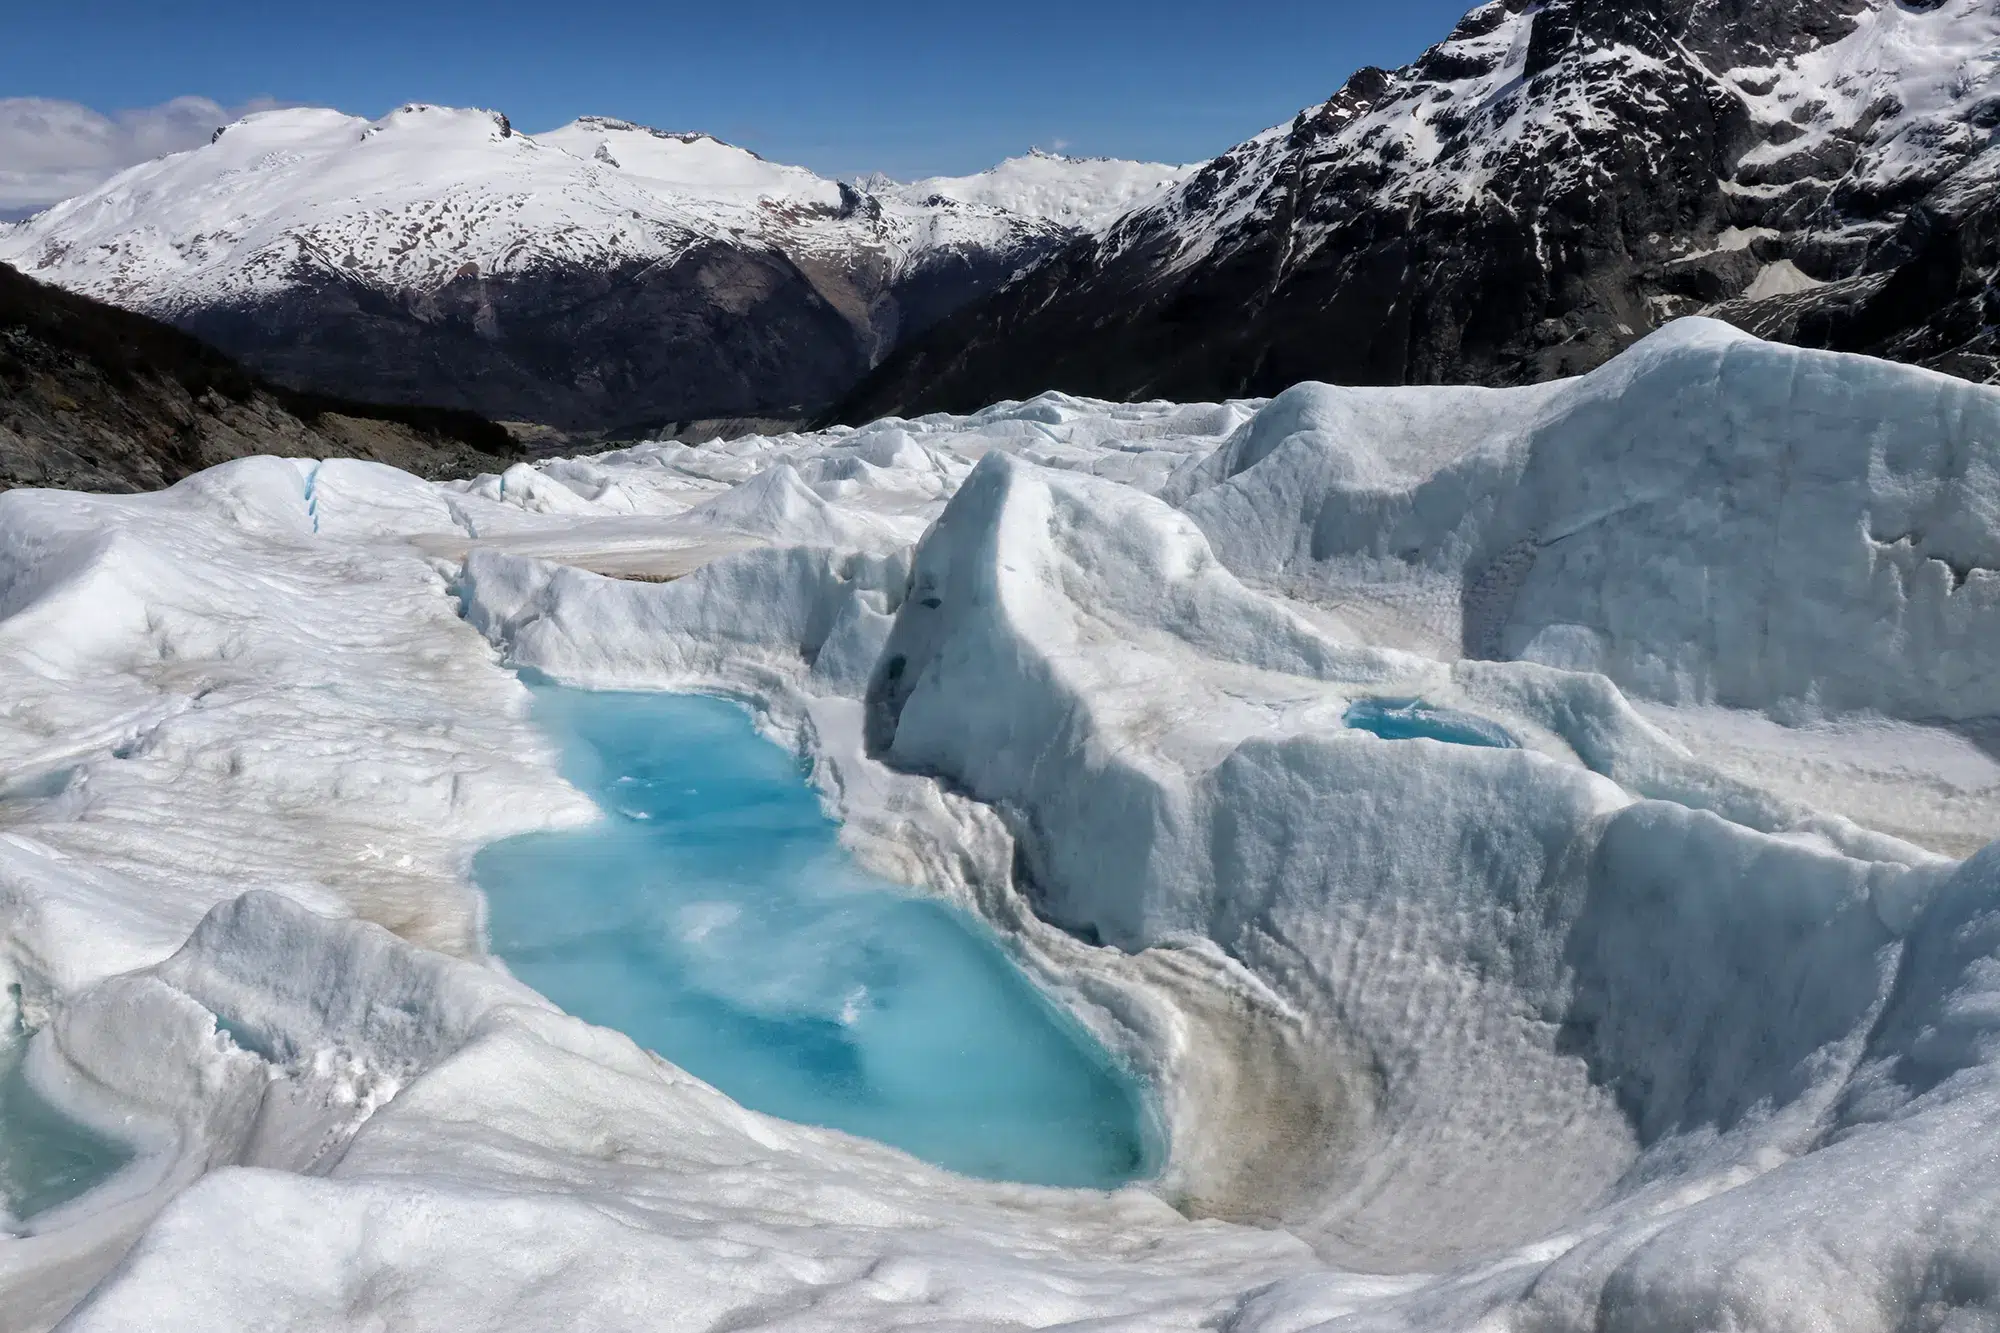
[176,228,1048,438]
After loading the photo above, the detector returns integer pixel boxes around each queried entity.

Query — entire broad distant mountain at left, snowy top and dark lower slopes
[0,104,1192,426]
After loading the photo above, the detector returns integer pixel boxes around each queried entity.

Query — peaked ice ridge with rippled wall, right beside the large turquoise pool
[870,458,1932,1267]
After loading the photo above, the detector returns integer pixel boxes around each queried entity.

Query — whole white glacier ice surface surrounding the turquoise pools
[0,320,2000,1333]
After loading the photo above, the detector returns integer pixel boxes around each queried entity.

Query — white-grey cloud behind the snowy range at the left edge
[0,98,278,216]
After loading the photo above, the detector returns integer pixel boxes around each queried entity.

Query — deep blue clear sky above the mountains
[0,0,1472,188]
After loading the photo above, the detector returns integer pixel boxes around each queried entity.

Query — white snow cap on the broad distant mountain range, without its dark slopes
[0,104,1186,316]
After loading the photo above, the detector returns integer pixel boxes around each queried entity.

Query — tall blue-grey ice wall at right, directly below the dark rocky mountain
[1168,320,2000,721]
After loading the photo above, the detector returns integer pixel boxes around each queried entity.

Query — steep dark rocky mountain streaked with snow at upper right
[848,0,2000,420]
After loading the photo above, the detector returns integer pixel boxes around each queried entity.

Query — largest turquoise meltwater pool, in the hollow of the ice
[474,685,1158,1187]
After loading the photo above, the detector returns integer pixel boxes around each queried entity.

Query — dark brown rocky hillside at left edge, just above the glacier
[0,264,514,490]
